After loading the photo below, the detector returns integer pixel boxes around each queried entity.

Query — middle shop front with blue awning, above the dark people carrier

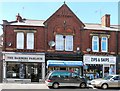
[47,60,83,75]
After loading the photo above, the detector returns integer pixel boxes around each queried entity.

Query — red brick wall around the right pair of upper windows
[82,30,116,54]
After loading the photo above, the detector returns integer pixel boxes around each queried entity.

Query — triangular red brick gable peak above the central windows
[44,3,85,27]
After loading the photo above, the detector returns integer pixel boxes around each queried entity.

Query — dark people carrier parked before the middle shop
[45,70,87,88]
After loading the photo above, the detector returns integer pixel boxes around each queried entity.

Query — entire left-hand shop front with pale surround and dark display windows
[3,52,45,82]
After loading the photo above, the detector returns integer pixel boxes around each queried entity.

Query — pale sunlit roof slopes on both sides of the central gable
[2,19,120,31]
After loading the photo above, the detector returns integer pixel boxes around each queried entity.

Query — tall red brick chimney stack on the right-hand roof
[101,14,110,27]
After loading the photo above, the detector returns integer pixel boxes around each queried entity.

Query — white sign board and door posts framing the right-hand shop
[83,55,116,77]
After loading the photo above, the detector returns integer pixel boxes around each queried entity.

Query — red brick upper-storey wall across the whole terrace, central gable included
[4,4,120,54]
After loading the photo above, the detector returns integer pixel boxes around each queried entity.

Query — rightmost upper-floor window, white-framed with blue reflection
[101,37,108,52]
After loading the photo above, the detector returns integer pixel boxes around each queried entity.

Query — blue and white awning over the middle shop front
[47,60,83,67]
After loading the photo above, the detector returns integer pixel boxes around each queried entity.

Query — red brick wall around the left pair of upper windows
[4,26,45,52]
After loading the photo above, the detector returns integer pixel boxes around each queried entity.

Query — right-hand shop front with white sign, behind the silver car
[83,55,116,79]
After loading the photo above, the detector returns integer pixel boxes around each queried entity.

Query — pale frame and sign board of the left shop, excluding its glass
[3,52,45,82]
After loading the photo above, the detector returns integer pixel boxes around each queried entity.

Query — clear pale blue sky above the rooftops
[0,0,118,34]
